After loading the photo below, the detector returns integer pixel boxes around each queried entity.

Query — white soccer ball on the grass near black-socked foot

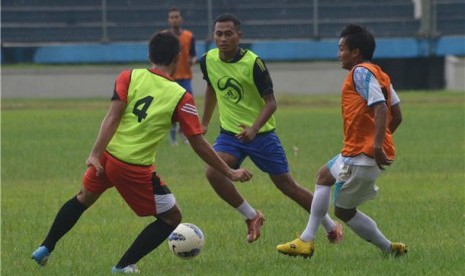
[168,223,205,259]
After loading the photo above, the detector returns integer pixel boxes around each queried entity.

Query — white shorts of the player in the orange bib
[327,154,381,209]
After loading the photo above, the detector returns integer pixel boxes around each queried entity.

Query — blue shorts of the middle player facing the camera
[213,131,289,175]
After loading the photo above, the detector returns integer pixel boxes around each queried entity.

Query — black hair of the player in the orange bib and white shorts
[340,24,376,60]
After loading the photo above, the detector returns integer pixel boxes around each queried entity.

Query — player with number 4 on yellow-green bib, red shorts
[32,32,252,274]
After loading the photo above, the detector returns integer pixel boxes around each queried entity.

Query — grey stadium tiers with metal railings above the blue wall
[1,0,465,45]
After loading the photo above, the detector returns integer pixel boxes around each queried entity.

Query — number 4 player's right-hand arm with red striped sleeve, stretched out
[174,93,252,182]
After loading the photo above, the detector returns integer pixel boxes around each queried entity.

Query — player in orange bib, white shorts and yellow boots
[276,25,407,257]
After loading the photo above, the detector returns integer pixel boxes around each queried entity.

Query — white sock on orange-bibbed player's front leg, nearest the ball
[300,185,334,242]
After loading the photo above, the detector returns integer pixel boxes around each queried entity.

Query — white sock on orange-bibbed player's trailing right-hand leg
[347,211,391,252]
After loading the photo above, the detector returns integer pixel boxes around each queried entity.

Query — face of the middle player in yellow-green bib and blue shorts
[213,21,242,53]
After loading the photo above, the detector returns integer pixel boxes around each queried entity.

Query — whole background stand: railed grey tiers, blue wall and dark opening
[1,0,465,89]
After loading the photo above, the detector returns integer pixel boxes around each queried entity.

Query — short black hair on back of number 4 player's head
[149,31,180,65]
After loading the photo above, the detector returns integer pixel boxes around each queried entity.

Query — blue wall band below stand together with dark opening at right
[1,36,465,90]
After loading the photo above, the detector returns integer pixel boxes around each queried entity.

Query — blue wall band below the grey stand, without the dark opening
[1,36,465,64]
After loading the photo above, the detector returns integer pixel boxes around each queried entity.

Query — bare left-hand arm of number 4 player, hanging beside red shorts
[86,100,126,175]
